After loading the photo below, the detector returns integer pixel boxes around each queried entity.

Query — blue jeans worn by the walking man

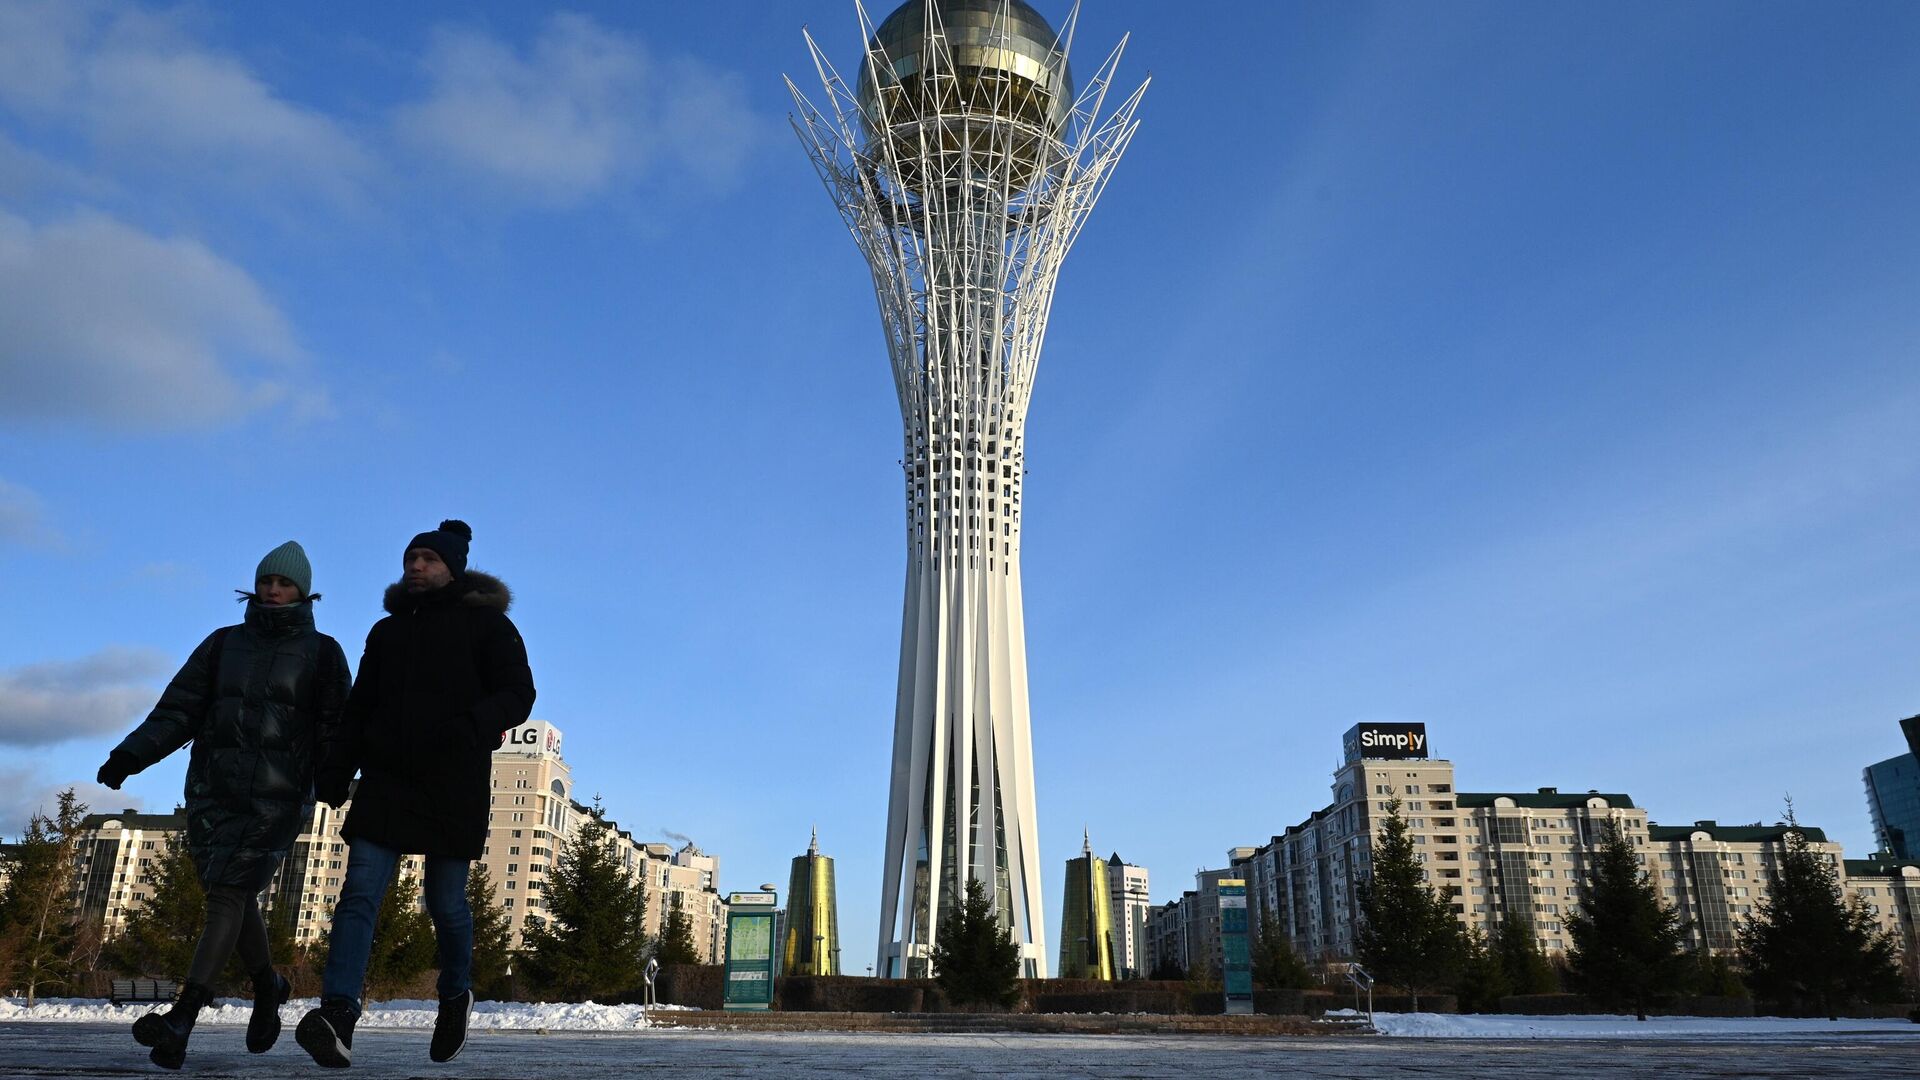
[321,838,474,1009]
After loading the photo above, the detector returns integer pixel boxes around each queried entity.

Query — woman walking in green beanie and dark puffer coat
[98,540,351,1068]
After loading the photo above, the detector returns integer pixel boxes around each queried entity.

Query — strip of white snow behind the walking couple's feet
[0,997,684,1032]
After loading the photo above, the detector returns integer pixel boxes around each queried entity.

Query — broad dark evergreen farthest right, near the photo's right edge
[1740,805,1901,1019]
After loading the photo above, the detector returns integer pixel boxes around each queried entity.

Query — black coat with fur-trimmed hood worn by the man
[323,571,534,859]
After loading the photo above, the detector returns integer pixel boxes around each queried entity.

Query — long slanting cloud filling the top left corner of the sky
[0,2,372,196]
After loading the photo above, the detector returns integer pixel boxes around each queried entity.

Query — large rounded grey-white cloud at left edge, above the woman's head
[0,211,324,430]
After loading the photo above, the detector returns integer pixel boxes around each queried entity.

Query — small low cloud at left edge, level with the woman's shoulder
[0,648,171,746]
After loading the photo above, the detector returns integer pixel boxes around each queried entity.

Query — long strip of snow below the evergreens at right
[1329,1009,1920,1042]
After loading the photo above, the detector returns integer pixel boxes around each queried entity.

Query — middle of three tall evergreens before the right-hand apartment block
[1567,821,1688,1020]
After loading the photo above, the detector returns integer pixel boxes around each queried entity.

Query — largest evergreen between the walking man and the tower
[522,799,648,1001]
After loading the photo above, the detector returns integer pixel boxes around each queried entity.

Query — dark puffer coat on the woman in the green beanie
[115,601,351,892]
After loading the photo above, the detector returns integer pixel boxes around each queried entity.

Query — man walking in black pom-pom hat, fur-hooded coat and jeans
[294,521,534,1068]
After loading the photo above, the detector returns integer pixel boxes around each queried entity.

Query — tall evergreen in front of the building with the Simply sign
[1354,799,1467,1009]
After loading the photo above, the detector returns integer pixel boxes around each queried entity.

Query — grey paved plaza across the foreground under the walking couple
[0,1022,1920,1080]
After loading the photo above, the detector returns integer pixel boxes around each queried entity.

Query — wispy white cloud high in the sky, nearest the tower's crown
[396,15,758,204]
